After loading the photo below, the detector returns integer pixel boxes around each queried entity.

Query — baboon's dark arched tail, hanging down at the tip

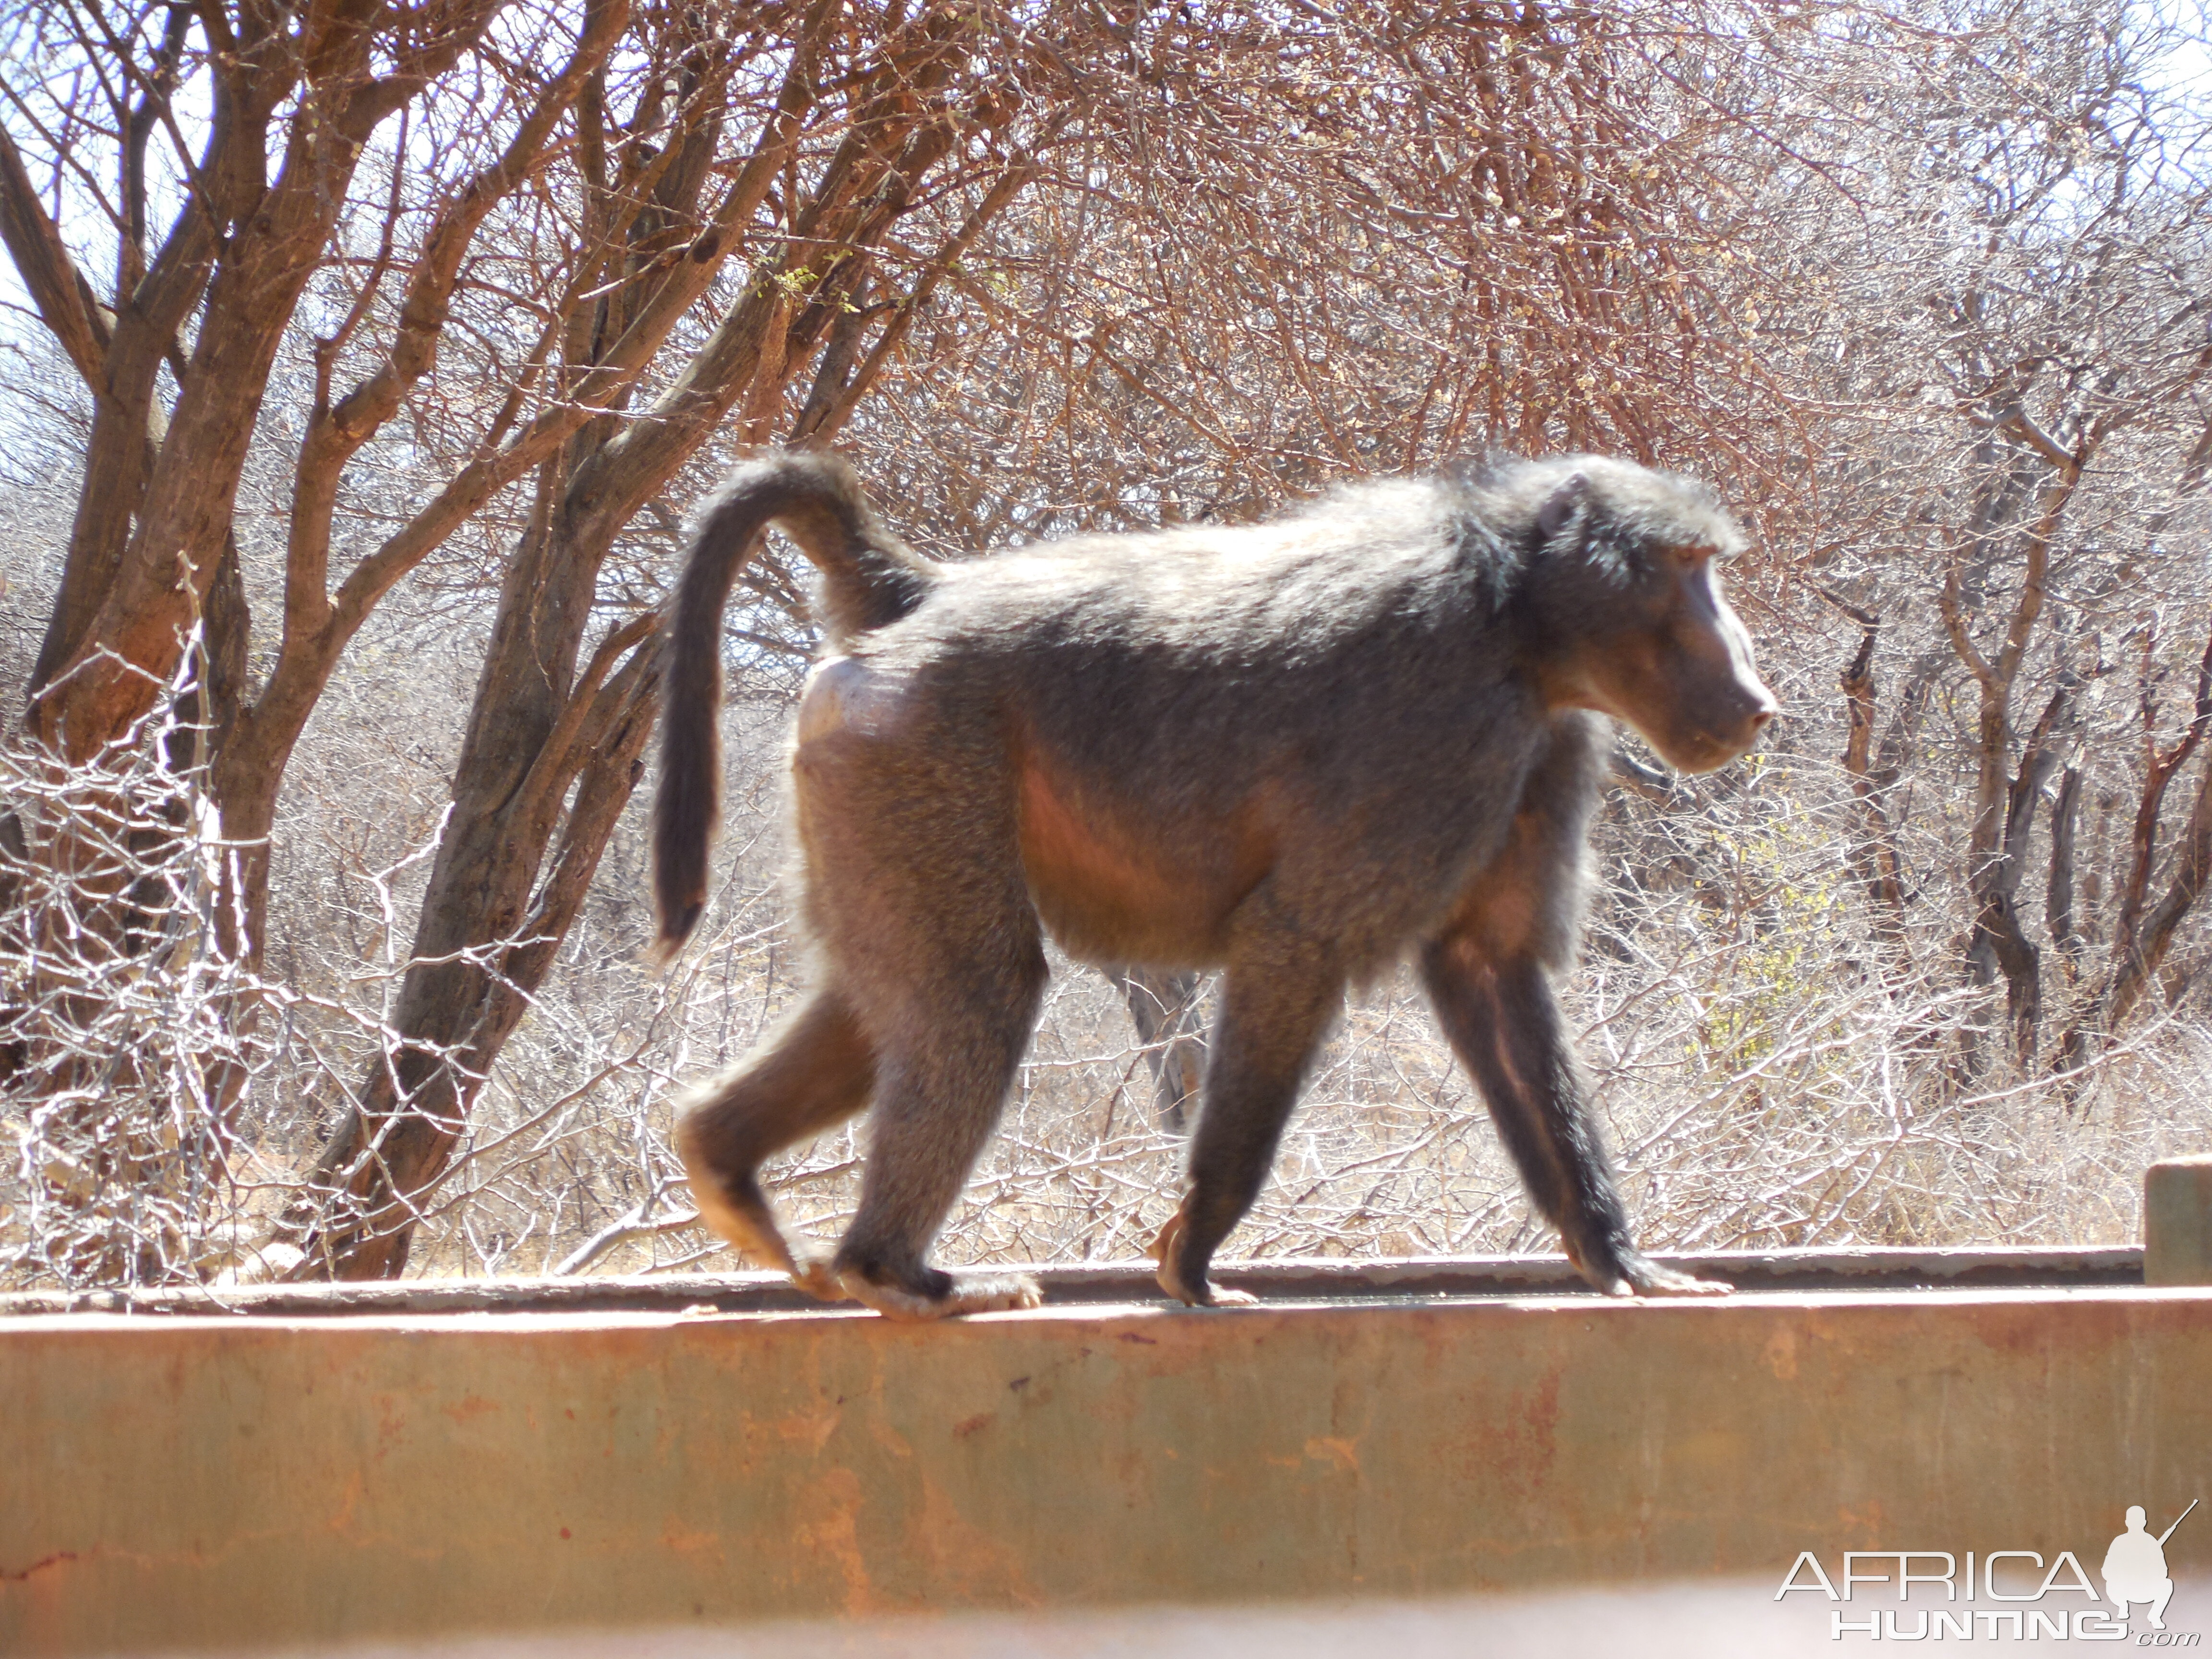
[652,451,936,962]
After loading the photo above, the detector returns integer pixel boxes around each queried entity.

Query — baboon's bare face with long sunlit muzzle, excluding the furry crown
[1557,540,1779,772]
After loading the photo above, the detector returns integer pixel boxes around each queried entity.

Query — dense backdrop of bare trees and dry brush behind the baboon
[0,0,2212,1283]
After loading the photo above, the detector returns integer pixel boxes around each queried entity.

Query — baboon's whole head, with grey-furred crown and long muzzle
[1531,458,1779,772]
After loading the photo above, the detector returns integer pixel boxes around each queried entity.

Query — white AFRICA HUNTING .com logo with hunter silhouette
[1774,1500,2203,1648]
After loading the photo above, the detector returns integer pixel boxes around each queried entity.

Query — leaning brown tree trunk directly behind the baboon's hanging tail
[290,13,1031,1278]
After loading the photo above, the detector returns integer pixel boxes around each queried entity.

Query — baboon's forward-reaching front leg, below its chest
[1422,938,1730,1296]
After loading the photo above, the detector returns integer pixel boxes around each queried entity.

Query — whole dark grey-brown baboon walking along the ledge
[652,454,1776,1318]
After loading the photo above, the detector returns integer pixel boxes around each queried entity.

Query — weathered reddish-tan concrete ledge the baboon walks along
[0,1263,2212,1655]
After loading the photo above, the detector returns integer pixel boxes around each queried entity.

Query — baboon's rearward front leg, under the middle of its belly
[1153,964,1343,1307]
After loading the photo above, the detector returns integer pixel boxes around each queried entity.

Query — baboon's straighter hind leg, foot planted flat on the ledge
[836,938,1046,1318]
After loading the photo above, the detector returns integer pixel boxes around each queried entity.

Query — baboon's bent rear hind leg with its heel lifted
[674,989,876,1301]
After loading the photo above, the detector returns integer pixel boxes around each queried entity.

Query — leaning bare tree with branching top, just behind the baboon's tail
[303,7,1070,1276]
